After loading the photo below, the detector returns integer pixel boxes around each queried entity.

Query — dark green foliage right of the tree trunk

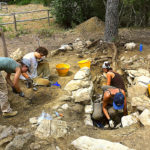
[120,0,150,27]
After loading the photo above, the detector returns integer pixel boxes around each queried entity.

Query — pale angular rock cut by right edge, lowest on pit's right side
[139,109,150,126]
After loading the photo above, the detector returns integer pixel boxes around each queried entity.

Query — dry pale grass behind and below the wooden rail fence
[1,4,64,34]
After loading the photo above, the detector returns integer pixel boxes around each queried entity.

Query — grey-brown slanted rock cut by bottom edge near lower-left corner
[5,133,34,150]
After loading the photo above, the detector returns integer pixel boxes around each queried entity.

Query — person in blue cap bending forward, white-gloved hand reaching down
[100,88,127,128]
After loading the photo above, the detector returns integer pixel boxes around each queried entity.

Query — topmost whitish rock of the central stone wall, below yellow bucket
[74,67,90,80]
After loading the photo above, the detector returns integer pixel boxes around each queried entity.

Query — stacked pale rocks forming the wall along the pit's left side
[64,67,94,126]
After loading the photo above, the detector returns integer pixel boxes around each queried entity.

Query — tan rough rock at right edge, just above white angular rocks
[131,96,150,111]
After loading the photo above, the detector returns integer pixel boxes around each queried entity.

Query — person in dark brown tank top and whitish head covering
[102,61,126,91]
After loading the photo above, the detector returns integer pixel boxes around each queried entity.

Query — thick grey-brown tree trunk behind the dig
[104,0,119,42]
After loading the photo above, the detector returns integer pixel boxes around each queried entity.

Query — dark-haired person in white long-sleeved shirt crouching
[20,47,50,88]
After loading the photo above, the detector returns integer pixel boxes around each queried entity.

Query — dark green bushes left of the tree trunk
[51,0,105,27]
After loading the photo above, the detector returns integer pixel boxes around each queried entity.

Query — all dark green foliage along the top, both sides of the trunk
[9,0,150,27]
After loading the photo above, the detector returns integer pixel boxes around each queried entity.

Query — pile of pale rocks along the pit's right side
[121,68,150,127]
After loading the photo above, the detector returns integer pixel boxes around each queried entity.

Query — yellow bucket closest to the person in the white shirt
[56,64,70,76]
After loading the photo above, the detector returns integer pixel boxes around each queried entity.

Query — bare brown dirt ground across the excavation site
[0,5,150,150]
